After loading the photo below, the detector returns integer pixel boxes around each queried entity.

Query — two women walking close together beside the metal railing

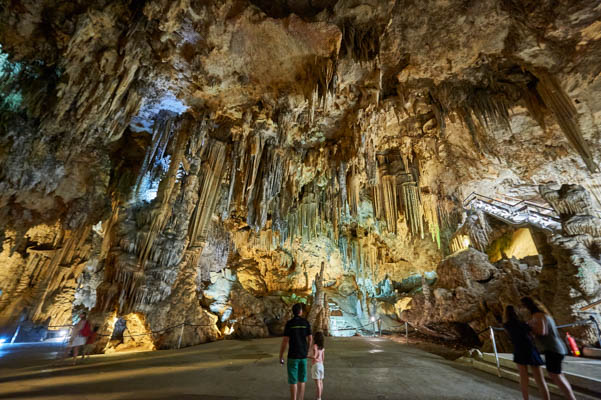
[504,297,576,400]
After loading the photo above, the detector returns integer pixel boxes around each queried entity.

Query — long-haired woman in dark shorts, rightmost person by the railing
[522,297,576,400]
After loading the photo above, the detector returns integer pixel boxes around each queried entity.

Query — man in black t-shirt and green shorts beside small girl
[280,303,313,400]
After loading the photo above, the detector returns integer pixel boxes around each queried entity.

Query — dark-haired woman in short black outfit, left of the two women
[503,306,550,400]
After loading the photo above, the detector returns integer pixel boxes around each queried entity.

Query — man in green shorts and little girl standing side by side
[280,303,325,400]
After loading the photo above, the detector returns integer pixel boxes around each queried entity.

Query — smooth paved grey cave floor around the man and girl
[0,337,564,400]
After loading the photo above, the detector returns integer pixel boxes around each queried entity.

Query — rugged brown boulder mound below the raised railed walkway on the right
[402,248,540,344]
